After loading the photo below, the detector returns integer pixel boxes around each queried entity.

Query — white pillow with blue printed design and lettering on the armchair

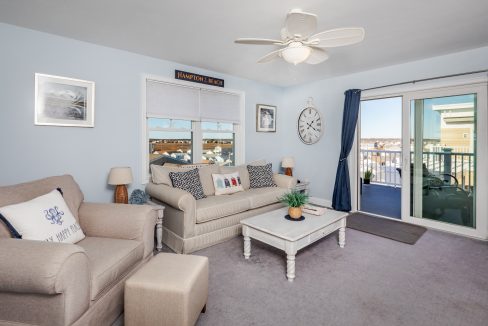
[0,189,85,243]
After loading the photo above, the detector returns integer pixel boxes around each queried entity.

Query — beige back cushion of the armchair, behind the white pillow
[0,175,83,237]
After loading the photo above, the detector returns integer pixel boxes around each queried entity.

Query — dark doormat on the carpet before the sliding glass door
[347,212,427,245]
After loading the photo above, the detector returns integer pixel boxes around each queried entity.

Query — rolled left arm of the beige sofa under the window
[146,182,196,214]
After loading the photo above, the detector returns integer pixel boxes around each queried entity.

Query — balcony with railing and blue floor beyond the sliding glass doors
[359,149,475,225]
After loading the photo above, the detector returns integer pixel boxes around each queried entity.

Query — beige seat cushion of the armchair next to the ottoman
[77,237,144,300]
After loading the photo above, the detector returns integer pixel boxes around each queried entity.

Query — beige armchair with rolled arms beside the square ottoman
[0,175,157,325]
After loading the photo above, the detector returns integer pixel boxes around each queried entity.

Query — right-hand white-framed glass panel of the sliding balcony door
[402,84,487,237]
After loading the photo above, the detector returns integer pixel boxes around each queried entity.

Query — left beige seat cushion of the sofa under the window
[196,192,251,223]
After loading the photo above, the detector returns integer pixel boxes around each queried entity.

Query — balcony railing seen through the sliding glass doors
[360,149,476,191]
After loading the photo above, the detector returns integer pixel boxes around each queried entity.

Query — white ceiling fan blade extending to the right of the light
[308,27,364,48]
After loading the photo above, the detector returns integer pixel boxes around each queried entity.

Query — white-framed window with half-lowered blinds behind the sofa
[143,78,244,180]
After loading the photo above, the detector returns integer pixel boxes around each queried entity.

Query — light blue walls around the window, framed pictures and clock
[0,24,488,201]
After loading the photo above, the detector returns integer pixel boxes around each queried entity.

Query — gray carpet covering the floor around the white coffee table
[191,229,488,326]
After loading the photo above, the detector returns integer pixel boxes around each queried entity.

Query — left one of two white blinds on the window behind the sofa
[146,79,200,121]
